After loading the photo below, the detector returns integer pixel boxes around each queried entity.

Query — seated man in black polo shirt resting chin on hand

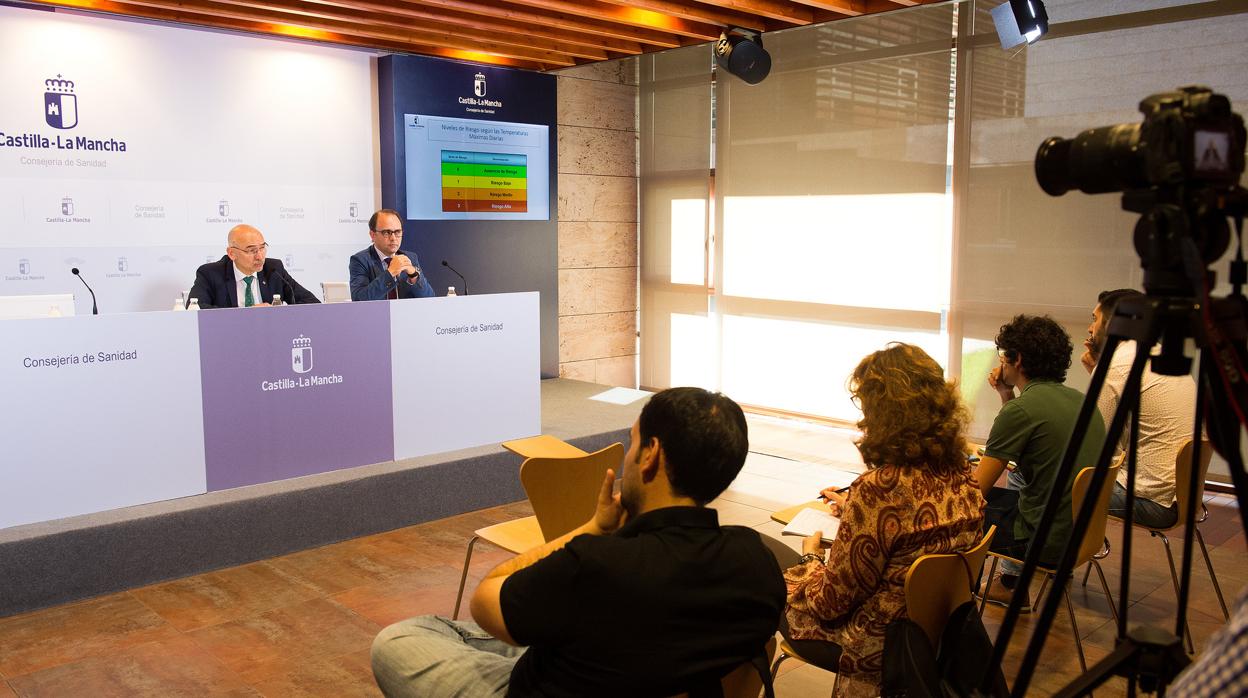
[373,388,785,697]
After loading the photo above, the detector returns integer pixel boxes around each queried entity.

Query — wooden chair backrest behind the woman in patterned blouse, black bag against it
[905,526,997,647]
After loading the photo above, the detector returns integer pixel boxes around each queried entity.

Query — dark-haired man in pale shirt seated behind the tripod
[1080,288,1196,528]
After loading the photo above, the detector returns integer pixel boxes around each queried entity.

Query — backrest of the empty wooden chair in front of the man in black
[520,443,624,541]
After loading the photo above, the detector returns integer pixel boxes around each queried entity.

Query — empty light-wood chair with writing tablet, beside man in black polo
[451,436,624,618]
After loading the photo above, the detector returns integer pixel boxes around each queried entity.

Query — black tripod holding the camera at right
[981,211,1248,697]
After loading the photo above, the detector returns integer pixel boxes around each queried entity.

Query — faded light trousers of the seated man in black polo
[373,616,525,698]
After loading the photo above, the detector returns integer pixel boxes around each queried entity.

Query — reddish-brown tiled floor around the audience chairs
[0,417,1248,698]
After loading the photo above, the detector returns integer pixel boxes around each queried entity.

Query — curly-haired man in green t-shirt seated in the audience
[975,315,1104,611]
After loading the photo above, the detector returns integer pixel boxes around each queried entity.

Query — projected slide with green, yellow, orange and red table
[403,114,550,221]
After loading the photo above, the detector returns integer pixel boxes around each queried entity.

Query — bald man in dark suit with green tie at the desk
[187,225,321,308]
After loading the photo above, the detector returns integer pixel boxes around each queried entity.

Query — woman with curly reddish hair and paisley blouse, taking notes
[781,343,983,696]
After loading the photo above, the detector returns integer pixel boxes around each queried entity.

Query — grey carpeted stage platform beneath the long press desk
[0,378,645,617]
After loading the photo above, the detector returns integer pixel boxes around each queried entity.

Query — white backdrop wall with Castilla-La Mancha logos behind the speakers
[0,7,379,313]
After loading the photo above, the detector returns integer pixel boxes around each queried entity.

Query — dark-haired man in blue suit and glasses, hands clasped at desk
[349,209,433,301]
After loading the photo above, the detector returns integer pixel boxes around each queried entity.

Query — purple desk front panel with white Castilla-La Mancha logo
[198,303,394,492]
